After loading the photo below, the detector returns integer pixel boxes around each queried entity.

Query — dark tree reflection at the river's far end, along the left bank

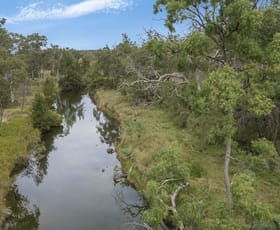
[57,93,84,135]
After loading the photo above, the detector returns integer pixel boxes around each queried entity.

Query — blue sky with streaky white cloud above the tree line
[0,0,186,50]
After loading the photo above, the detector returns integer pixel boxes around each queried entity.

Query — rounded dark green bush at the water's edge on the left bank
[31,94,62,132]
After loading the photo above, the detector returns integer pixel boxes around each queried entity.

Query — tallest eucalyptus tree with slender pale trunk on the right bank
[154,0,280,208]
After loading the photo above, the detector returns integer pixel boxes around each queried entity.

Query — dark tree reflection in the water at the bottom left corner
[4,185,40,230]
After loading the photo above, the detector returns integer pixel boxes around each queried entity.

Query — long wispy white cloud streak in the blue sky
[7,0,132,23]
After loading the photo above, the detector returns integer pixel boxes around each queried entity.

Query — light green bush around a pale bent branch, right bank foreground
[143,147,190,227]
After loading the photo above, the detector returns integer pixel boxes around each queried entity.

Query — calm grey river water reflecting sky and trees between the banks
[4,95,143,230]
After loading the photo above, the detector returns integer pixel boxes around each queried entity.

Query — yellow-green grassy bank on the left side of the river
[0,83,40,226]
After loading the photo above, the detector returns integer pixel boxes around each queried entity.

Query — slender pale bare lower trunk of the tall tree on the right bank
[224,137,232,210]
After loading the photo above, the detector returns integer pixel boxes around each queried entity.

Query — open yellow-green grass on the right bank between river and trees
[95,90,280,227]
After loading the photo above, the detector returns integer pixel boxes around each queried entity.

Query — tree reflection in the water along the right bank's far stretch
[93,108,120,146]
